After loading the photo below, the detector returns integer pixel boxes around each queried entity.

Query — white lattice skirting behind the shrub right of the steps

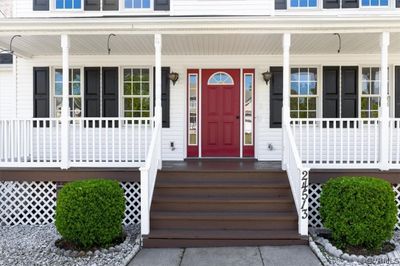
[308,184,400,230]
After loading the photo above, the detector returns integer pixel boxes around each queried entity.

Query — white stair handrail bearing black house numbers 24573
[283,122,310,236]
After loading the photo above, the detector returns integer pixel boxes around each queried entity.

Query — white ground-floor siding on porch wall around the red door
[9,51,400,160]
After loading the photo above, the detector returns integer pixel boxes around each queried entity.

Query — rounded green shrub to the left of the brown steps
[55,179,125,249]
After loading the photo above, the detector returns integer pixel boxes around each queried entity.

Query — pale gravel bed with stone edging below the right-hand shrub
[310,231,400,266]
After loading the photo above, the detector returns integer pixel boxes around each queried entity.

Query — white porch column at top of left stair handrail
[154,34,162,169]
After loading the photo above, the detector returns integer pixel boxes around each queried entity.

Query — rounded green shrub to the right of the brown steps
[320,177,397,250]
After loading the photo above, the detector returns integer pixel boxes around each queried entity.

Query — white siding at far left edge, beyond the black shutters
[0,68,16,119]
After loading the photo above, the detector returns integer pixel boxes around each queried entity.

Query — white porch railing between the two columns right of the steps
[290,118,380,168]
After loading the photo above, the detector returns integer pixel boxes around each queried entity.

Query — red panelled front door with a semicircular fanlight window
[201,69,240,157]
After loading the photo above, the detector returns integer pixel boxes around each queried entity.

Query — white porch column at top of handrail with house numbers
[282,33,291,170]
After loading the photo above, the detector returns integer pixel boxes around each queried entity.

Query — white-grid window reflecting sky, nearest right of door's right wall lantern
[290,68,318,118]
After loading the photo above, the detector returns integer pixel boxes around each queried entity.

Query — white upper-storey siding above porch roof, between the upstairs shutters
[171,0,274,16]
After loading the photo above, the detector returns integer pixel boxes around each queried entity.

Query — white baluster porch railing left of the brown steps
[0,118,154,167]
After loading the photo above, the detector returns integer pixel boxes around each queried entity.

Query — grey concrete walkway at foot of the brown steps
[129,246,321,266]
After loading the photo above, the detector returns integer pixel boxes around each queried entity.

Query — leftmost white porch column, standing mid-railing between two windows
[61,34,70,169]
